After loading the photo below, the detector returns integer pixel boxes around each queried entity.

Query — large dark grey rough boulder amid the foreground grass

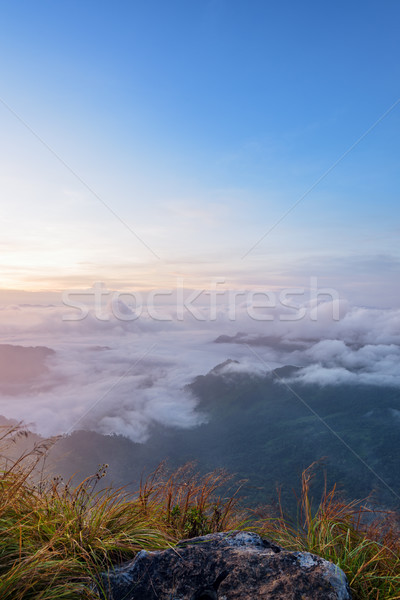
[102,532,351,600]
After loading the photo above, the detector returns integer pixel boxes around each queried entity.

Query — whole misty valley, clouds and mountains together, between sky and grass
[0,301,400,507]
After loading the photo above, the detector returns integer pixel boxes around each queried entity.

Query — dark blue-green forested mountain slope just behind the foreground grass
[47,361,400,506]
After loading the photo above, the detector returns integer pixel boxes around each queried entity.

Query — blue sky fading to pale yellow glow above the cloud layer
[0,0,400,306]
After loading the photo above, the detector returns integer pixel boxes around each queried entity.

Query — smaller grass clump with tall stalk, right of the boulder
[258,465,400,600]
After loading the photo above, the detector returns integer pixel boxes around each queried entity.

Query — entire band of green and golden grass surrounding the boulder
[0,428,400,600]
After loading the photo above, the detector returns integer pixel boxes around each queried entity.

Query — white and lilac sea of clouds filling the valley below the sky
[0,290,400,442]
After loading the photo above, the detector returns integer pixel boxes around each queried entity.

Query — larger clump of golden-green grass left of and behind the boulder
[0,428,243,600]
